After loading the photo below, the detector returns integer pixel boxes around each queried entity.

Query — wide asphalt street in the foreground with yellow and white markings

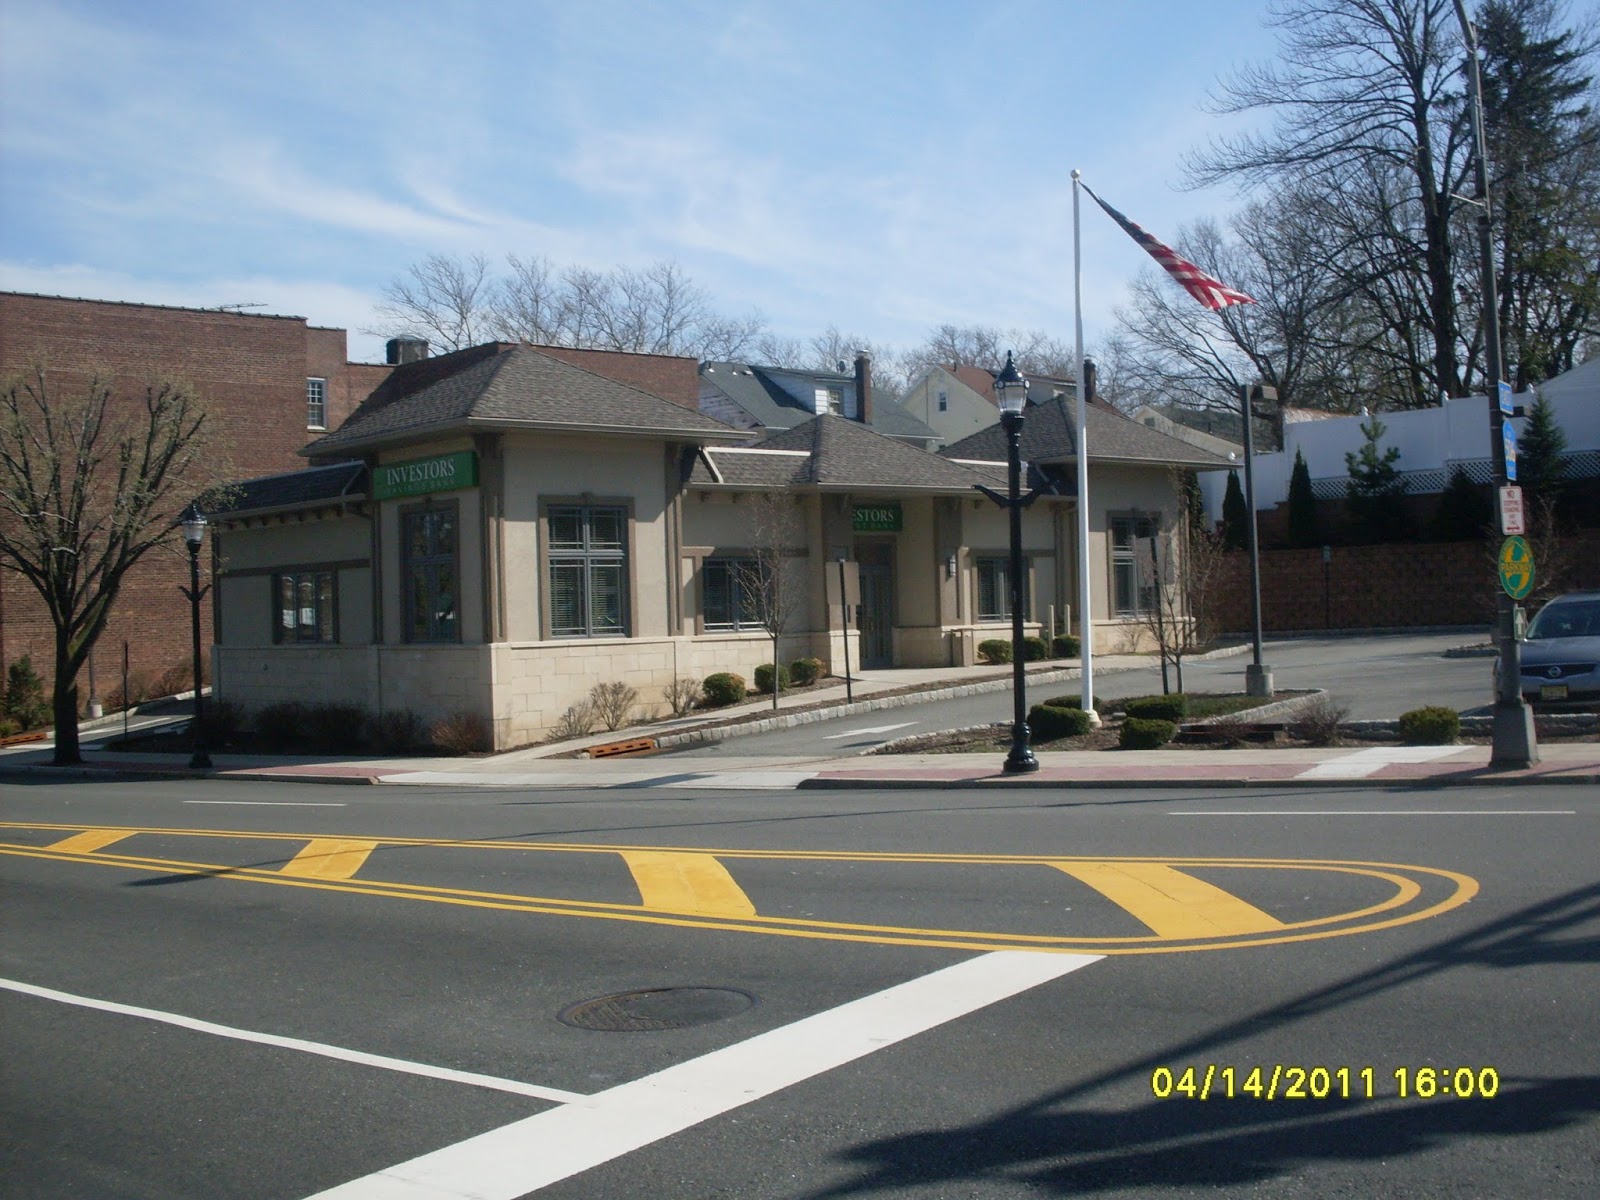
[0,781,1600,1200]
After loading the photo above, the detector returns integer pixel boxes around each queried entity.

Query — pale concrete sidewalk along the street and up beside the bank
[0,646,1600,790]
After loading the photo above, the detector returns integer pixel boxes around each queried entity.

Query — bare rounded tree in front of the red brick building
[0,368,226,765]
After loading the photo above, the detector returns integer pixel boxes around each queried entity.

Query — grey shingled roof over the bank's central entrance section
[690,413,1003,494]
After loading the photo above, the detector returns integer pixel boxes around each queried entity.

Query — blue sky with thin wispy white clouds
[0,0,1275,360]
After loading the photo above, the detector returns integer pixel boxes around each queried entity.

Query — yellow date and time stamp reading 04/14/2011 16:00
[1150,1062,1499,1101]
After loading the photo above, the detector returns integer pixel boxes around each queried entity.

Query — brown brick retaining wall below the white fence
[1221,530,1600,632]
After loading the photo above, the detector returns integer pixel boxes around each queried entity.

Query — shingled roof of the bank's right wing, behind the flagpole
[939,397,1229,470]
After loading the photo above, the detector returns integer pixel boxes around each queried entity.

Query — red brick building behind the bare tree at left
[0,293,392,699]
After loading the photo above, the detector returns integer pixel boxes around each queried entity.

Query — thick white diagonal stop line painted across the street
[300,950,1101,1200]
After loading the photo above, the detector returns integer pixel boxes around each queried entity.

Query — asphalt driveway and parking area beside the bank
[670,632,1494,758]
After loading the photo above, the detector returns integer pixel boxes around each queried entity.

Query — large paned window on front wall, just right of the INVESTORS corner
[547,506,627,637]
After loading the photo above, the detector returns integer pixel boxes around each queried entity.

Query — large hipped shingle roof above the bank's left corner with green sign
[301,342,741,458]
